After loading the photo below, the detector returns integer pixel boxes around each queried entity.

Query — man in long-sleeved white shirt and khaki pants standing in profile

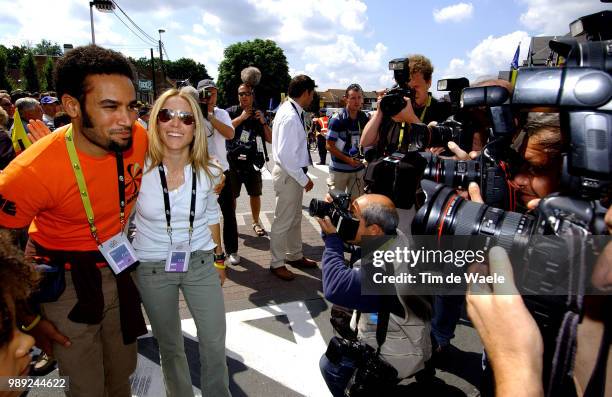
[270,75,317,281]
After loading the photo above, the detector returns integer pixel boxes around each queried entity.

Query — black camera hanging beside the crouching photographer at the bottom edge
[325,336,399,397]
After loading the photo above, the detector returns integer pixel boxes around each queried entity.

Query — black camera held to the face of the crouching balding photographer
[308,191,359,242]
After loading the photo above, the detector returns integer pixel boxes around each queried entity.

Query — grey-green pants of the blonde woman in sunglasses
[136,251,230,397]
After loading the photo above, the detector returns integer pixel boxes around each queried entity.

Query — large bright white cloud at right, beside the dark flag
[440,31,530,81]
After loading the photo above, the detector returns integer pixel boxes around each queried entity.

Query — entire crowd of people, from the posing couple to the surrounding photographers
[0,46,612,397]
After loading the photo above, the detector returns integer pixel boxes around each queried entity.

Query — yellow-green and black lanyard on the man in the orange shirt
[65,126,125,245]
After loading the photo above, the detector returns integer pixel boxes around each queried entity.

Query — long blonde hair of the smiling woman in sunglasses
[146,88,221,180]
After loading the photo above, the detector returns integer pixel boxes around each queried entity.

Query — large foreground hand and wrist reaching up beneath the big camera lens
[466,247,544,396]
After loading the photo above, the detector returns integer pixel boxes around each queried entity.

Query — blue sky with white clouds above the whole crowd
[0,0,610,94]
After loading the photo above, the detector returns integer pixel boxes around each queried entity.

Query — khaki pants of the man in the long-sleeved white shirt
[270,164,304,268]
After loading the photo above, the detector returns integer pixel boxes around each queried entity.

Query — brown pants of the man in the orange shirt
[42,265,137,397]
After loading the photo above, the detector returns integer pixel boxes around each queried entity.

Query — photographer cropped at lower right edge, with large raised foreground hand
[467,203,612,396]
